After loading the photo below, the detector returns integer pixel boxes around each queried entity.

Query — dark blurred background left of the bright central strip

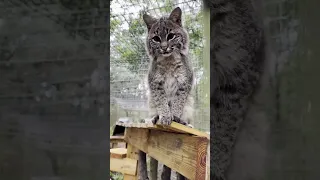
[0,0,110,180]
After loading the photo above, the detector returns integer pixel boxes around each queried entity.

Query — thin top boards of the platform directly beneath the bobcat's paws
[117,122,210,139]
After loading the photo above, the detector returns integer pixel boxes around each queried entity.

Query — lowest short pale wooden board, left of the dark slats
[110,158,137,175]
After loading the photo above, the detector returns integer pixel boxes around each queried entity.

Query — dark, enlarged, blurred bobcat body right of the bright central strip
[206,0,265,180]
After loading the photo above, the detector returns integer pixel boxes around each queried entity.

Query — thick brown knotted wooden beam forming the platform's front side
[125,128,209,180]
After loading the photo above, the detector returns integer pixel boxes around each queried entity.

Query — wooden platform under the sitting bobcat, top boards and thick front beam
[112,122,210,180]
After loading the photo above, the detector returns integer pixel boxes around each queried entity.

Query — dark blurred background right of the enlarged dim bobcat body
[225,0,320,180]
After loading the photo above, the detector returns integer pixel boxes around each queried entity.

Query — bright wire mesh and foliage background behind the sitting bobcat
[110,0,210,132]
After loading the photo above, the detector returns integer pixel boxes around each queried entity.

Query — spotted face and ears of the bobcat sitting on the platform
[143,8,188,57]
